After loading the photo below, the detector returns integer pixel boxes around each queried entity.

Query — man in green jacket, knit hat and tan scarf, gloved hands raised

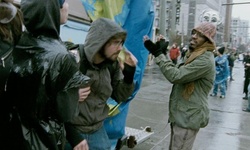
[144,23,216,150]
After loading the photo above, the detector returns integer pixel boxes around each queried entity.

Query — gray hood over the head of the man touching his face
[84,18,126,64]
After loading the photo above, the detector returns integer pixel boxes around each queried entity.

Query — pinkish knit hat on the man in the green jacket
[193,22,216,44]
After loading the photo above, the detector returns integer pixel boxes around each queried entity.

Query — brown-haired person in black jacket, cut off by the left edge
[0,0,23,149]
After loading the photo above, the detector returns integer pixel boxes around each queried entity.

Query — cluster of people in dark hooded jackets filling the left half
[0,0,137,150]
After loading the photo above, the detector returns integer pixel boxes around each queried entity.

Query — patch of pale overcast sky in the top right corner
[232,0,250,22]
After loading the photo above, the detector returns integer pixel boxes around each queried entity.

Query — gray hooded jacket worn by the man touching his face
[69,18,135,133]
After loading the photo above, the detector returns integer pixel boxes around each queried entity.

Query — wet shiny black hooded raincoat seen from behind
[7,0,89,149]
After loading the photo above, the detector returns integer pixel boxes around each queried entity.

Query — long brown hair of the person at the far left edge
[0,8,23,44]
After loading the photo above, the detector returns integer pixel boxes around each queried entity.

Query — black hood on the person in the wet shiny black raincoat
[21,0,60,38]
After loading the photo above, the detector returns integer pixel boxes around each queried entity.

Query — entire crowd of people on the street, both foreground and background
[0,0,250,150]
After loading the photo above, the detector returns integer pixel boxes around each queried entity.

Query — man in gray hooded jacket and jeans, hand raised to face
[65,18,137,150]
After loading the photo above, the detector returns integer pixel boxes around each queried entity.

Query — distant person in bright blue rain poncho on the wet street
[210,47,229,98]
